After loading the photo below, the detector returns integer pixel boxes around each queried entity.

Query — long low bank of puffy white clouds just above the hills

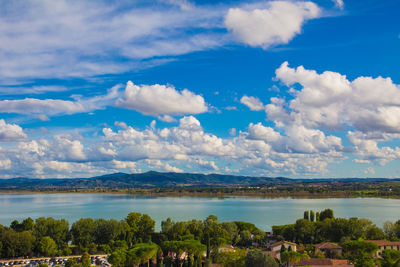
[0,116,343,177]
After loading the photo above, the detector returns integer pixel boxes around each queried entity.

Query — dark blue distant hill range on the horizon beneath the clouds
[0,171,400,190]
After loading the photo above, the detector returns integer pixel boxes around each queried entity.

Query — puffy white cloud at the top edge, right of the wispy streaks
[225,1,320,49]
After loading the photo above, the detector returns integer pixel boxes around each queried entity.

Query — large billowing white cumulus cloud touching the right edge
[276,62,400,133]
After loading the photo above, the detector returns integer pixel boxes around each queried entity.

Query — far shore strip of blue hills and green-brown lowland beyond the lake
[0,172,400,197]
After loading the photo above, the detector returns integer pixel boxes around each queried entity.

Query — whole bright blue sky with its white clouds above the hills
[0,0,400,178]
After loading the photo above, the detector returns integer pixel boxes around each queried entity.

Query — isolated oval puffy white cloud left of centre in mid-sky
[117,81,208,118]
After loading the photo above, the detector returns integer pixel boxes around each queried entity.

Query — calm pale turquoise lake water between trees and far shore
[0,194,400,230]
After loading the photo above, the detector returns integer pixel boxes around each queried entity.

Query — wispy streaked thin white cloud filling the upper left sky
[0,0,226,80]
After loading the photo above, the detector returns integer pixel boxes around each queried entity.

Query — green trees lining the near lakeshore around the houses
[0,209,400,267]
